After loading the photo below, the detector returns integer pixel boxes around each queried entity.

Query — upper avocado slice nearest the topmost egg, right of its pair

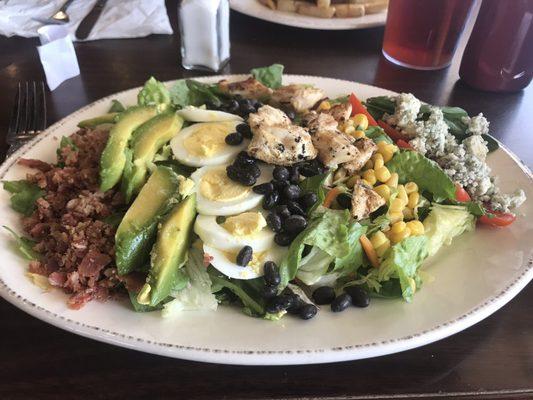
[122,111,183,202]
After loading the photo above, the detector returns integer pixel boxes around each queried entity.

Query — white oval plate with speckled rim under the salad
[0,75,533,365]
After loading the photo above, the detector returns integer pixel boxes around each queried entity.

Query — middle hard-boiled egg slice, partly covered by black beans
[191,165,272,215]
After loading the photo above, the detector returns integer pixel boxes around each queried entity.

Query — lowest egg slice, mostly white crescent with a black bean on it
[204,244,287,279]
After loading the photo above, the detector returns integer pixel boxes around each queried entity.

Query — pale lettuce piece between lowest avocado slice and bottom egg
[162,247,218,317]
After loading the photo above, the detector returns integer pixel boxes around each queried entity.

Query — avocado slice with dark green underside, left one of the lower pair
[115,166,180,275]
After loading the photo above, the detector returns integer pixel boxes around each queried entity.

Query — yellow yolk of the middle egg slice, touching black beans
[200,166,252,201]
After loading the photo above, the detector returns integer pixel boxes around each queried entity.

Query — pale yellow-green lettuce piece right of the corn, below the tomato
[424,204,475,256]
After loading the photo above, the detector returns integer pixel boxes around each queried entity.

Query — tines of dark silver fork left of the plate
[6,81,46,156]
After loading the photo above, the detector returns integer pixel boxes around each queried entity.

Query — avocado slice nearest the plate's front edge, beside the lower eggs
[137,194,196,307]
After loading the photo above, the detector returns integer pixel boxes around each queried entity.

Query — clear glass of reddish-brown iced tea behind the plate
[383,0,474,70]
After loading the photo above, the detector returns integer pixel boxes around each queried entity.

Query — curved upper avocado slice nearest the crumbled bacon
[100,106,157,192]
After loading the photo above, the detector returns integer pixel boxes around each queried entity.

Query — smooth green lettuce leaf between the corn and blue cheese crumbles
[387,150,455,202]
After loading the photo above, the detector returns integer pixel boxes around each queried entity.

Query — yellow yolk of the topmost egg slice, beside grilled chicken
[183,122,235,157]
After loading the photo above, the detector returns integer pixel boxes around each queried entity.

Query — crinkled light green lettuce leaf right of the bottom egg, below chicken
[280,209,366,288]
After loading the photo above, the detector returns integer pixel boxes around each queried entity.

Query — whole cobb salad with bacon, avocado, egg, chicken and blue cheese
[3,64,525,320]
